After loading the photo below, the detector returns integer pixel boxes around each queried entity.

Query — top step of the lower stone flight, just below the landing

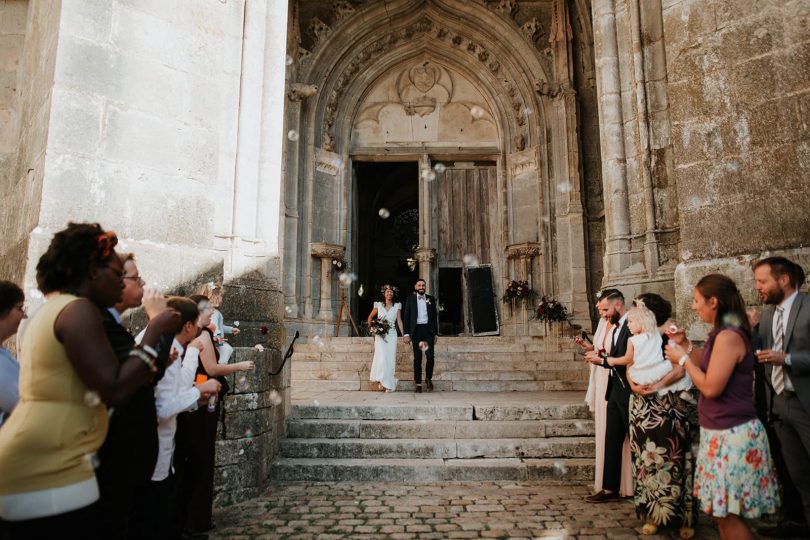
[287,419,594,439]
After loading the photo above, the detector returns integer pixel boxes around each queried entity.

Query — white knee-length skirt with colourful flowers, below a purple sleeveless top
[695,420,781,518]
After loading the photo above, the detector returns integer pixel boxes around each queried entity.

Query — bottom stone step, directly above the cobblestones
[272,458,594,484]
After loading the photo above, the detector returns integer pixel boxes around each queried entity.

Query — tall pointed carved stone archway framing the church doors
[284,0,588,333]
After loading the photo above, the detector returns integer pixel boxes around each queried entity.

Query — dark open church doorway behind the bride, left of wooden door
[353,161,419,322]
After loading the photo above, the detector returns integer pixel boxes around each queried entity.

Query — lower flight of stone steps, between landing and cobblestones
[273,392,594,483]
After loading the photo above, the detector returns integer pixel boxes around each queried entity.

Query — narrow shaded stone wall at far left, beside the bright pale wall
[0,0,56,282]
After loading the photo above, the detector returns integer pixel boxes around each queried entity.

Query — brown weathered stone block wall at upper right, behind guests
[663,0,810,330]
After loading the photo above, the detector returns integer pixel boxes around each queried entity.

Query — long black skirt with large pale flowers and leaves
[630,392,697,527]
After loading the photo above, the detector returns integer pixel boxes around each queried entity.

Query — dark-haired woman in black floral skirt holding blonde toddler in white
[624,293,697,539]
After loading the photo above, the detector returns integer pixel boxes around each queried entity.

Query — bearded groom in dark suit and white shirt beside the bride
[403,278,439,394]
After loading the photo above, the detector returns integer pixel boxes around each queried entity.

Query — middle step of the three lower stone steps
[280,437,594,459]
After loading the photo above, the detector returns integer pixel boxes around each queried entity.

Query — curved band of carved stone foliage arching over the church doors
[321,15,528,151]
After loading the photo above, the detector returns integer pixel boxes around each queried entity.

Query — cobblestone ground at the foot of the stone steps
[211,482,732,540]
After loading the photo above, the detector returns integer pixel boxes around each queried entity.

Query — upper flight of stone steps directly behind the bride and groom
[291,336,588,392]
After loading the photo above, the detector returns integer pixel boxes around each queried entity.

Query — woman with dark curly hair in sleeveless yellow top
[0,223,178,539]
